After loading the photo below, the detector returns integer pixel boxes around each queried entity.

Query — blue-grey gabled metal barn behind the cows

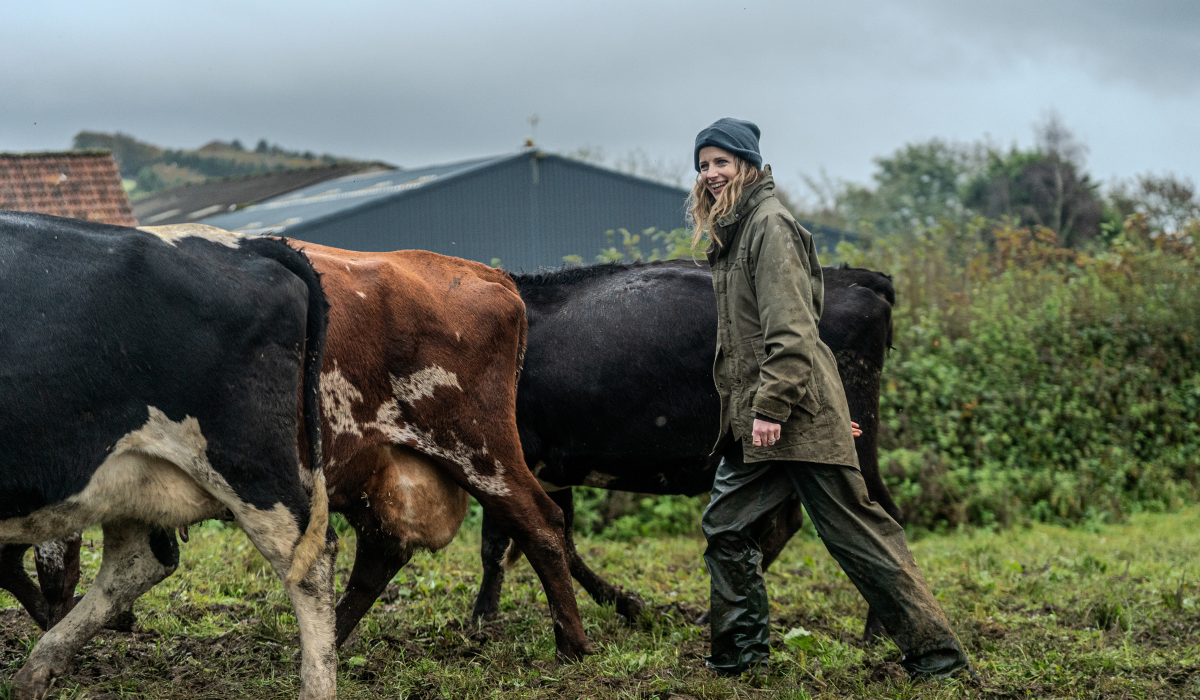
[199,149,688,270]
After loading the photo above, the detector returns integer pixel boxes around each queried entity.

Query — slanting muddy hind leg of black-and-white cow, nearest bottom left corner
[14,520,179,700]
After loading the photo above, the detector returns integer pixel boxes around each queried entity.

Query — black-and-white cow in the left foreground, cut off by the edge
[0,211,337,699]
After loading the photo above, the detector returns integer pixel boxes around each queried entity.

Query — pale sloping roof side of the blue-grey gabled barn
[203,154,516,234]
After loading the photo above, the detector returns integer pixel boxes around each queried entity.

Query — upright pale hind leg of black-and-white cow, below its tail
[233,501,337,700]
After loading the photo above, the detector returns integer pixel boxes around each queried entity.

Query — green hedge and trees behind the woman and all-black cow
[561,119,1200,539]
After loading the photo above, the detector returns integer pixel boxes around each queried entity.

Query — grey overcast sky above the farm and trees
[0,0,1200,195]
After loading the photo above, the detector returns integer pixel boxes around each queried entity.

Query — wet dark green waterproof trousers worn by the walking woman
[703,442,967,677]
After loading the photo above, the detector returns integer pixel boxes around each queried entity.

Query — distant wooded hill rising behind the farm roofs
[73,131,360,201]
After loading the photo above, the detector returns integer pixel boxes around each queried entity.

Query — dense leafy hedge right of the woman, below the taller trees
[839,216,1200,528]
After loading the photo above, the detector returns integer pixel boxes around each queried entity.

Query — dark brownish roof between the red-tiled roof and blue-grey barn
[133,163,395,226]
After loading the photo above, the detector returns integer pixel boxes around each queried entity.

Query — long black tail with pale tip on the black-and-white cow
[242,238,329,586]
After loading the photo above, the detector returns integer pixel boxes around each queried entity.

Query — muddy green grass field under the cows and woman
[0,508,1200,700]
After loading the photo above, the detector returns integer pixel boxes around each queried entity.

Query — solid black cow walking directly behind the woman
[474,261,904,639]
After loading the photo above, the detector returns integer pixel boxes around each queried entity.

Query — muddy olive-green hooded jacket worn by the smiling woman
[708,166,858,468]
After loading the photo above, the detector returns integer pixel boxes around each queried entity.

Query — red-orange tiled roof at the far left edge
[0,151,138,226]
